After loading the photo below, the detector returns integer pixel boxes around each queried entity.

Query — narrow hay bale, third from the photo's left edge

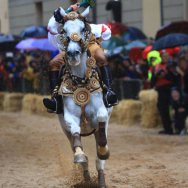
[22,94,37,114]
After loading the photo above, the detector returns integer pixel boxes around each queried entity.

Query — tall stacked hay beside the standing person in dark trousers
[139,89,160,128]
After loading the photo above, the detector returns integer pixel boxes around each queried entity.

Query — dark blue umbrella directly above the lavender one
[20,26,48,38]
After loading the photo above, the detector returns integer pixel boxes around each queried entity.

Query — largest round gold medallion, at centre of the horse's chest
[73,88,90,106]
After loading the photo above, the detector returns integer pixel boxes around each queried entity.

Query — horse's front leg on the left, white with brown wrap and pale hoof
[64,99,87,163]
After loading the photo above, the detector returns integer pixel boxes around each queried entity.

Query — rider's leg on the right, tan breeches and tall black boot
[89,43,118,107]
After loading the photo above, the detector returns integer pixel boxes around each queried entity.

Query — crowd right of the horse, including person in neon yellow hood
[110,47,188,135]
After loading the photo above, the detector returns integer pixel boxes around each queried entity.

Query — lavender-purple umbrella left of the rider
[16,38,57,51]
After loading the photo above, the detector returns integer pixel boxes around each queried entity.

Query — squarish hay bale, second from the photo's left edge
[3,93,23,112]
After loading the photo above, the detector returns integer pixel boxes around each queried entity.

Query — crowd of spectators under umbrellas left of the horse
[0,51,51,94]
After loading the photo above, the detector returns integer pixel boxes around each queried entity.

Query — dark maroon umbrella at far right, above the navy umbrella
[155,21,188,40]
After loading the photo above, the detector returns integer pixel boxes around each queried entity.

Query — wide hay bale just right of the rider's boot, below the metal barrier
[112,100,142,126]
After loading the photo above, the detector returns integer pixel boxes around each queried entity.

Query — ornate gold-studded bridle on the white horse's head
[58,12,92,52]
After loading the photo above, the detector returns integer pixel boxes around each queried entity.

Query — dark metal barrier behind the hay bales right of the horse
[113,79,143,100]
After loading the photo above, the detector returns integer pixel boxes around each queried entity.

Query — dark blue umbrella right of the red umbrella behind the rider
[122,27,147,42]
